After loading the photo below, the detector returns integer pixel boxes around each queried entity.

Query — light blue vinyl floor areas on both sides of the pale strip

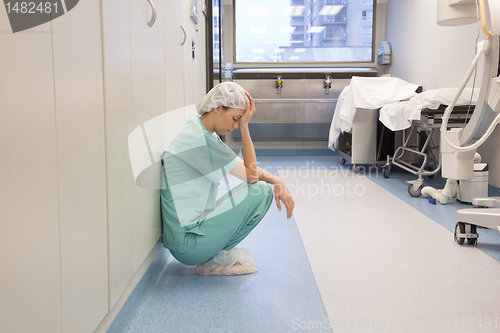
[108,153,500,333]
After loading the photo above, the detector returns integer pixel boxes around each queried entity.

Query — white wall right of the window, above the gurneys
[387,0,481,90]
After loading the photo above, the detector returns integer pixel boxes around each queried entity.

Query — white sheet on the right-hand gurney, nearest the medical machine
[379,88,479,131]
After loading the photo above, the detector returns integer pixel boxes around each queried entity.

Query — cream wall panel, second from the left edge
[52,1,108,333]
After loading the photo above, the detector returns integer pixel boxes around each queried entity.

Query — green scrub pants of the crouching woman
[170,181,274,269]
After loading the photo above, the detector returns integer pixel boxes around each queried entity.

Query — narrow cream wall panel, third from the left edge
[102,0,136,309]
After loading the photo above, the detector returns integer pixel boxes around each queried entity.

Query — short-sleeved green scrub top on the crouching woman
[161,116,239,253]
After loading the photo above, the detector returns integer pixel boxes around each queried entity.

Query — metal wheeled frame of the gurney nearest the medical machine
[382,105,474,197]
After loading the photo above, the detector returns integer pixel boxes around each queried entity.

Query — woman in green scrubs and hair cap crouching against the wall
[161,82,294,275]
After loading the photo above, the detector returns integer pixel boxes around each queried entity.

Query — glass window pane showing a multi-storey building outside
[234,0,374,63]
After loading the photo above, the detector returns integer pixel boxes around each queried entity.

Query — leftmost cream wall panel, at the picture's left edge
[0,16,61,333]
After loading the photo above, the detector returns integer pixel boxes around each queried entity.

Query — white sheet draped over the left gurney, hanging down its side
[328,76,418,150]
